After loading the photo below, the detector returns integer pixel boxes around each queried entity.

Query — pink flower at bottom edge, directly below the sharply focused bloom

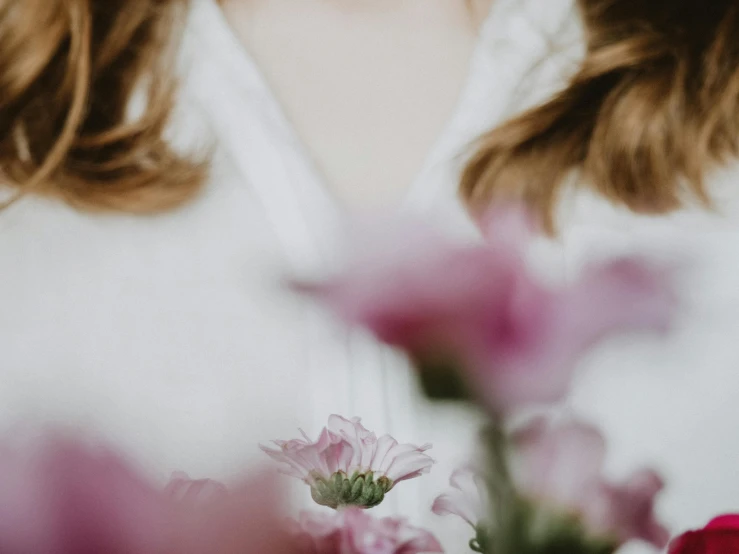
[295,507,443,554]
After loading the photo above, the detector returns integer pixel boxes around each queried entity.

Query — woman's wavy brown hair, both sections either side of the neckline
[0,0,739,224]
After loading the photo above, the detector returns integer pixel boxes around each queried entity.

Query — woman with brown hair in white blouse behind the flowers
[0,0,739,544]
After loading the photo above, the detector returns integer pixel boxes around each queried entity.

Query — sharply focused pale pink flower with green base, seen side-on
[261,415,434,508]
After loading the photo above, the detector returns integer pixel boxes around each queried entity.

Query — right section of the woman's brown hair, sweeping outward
[462,0,739,231]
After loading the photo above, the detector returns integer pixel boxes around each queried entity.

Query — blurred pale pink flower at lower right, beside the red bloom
[511,418,669,548]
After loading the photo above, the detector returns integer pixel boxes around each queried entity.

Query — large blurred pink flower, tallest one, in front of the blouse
[295,208,673,413]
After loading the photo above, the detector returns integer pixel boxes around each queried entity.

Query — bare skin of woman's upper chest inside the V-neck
[218,0,488,207]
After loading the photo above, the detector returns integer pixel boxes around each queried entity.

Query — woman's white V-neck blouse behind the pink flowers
[0,0,739,552]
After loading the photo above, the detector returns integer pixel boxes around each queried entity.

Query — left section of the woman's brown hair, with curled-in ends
[0,0,205,213]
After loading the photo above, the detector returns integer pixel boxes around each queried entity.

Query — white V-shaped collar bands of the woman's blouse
[184,0,573,271]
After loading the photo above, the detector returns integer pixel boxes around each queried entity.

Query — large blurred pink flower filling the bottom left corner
[0,437,298,554]
